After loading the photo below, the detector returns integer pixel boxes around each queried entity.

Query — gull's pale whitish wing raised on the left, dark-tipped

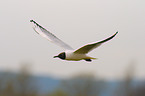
[30,20,73,50]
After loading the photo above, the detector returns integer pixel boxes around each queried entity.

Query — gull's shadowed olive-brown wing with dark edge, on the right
[74,32,118,54]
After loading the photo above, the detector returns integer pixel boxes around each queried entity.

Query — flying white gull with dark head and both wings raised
[30,20,118,62]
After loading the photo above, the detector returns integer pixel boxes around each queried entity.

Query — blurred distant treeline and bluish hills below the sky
[0,64,145,96]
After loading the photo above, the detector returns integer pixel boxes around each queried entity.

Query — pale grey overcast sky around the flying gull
[0,0,145,80]
